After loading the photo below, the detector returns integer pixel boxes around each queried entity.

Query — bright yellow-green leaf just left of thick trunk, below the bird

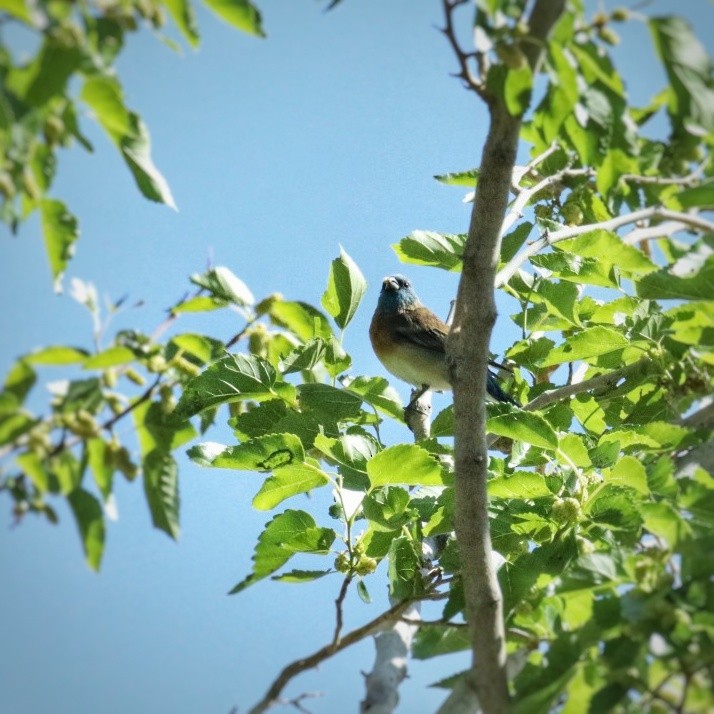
[367,444,446,488]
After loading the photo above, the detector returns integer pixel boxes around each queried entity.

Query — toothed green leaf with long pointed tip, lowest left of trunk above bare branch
[230,510,337,595]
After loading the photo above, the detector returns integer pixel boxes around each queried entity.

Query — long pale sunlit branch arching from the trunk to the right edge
[496,206,714,287]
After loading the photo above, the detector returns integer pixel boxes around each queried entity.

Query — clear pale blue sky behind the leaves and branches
[0,0,714,714]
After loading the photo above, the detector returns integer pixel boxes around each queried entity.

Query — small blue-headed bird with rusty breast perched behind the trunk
[369,275,519,406]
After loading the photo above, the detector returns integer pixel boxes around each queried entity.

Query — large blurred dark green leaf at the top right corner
[649,15,714,136]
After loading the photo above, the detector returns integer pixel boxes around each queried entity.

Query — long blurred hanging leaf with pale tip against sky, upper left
[80,75,176,209]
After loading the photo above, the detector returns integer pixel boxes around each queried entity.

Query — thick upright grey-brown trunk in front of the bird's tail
[447,0,565,714]
